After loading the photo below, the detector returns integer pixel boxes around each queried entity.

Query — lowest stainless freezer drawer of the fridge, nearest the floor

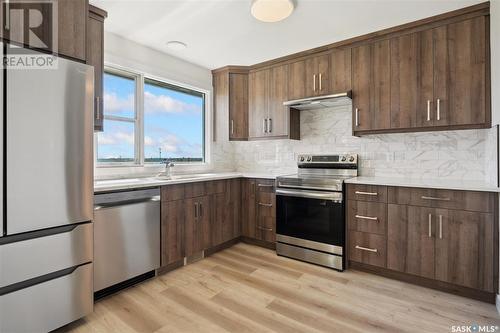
[0,264,93,333]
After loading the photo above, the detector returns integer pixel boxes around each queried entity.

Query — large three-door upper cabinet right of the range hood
[353,16,491,134]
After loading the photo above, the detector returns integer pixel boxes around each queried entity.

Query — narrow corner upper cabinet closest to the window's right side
[213,68,248,140]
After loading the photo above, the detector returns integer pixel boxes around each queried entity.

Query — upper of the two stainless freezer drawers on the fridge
[0,223,93,288]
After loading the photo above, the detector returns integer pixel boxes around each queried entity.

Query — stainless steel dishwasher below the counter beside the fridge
[94,188,161,298]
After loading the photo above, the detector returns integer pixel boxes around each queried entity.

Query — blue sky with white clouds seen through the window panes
[98,73,203,159]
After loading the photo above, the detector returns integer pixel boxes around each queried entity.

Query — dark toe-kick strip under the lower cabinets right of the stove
[348,261,498,309]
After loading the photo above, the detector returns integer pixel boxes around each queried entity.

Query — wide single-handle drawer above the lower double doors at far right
[388,187,496,212]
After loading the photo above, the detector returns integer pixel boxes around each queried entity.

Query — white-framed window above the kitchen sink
[96,68,205,166]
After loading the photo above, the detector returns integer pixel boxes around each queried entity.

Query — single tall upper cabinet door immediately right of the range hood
[352,40,390,133]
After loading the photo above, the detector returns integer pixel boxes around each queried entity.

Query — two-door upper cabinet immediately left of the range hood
[248,64,300,139]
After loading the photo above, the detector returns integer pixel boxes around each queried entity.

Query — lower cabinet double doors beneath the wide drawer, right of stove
[387,204,495,292]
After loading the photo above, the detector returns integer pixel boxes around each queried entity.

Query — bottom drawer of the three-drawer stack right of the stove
[349,231,387,267]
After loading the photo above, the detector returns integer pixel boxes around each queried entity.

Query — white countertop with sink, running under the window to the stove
[94,172,277,193]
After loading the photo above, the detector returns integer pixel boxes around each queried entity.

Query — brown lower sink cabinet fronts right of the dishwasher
[161,179,241,266]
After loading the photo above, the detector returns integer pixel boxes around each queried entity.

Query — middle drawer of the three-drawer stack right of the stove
[347,200,387,235]
